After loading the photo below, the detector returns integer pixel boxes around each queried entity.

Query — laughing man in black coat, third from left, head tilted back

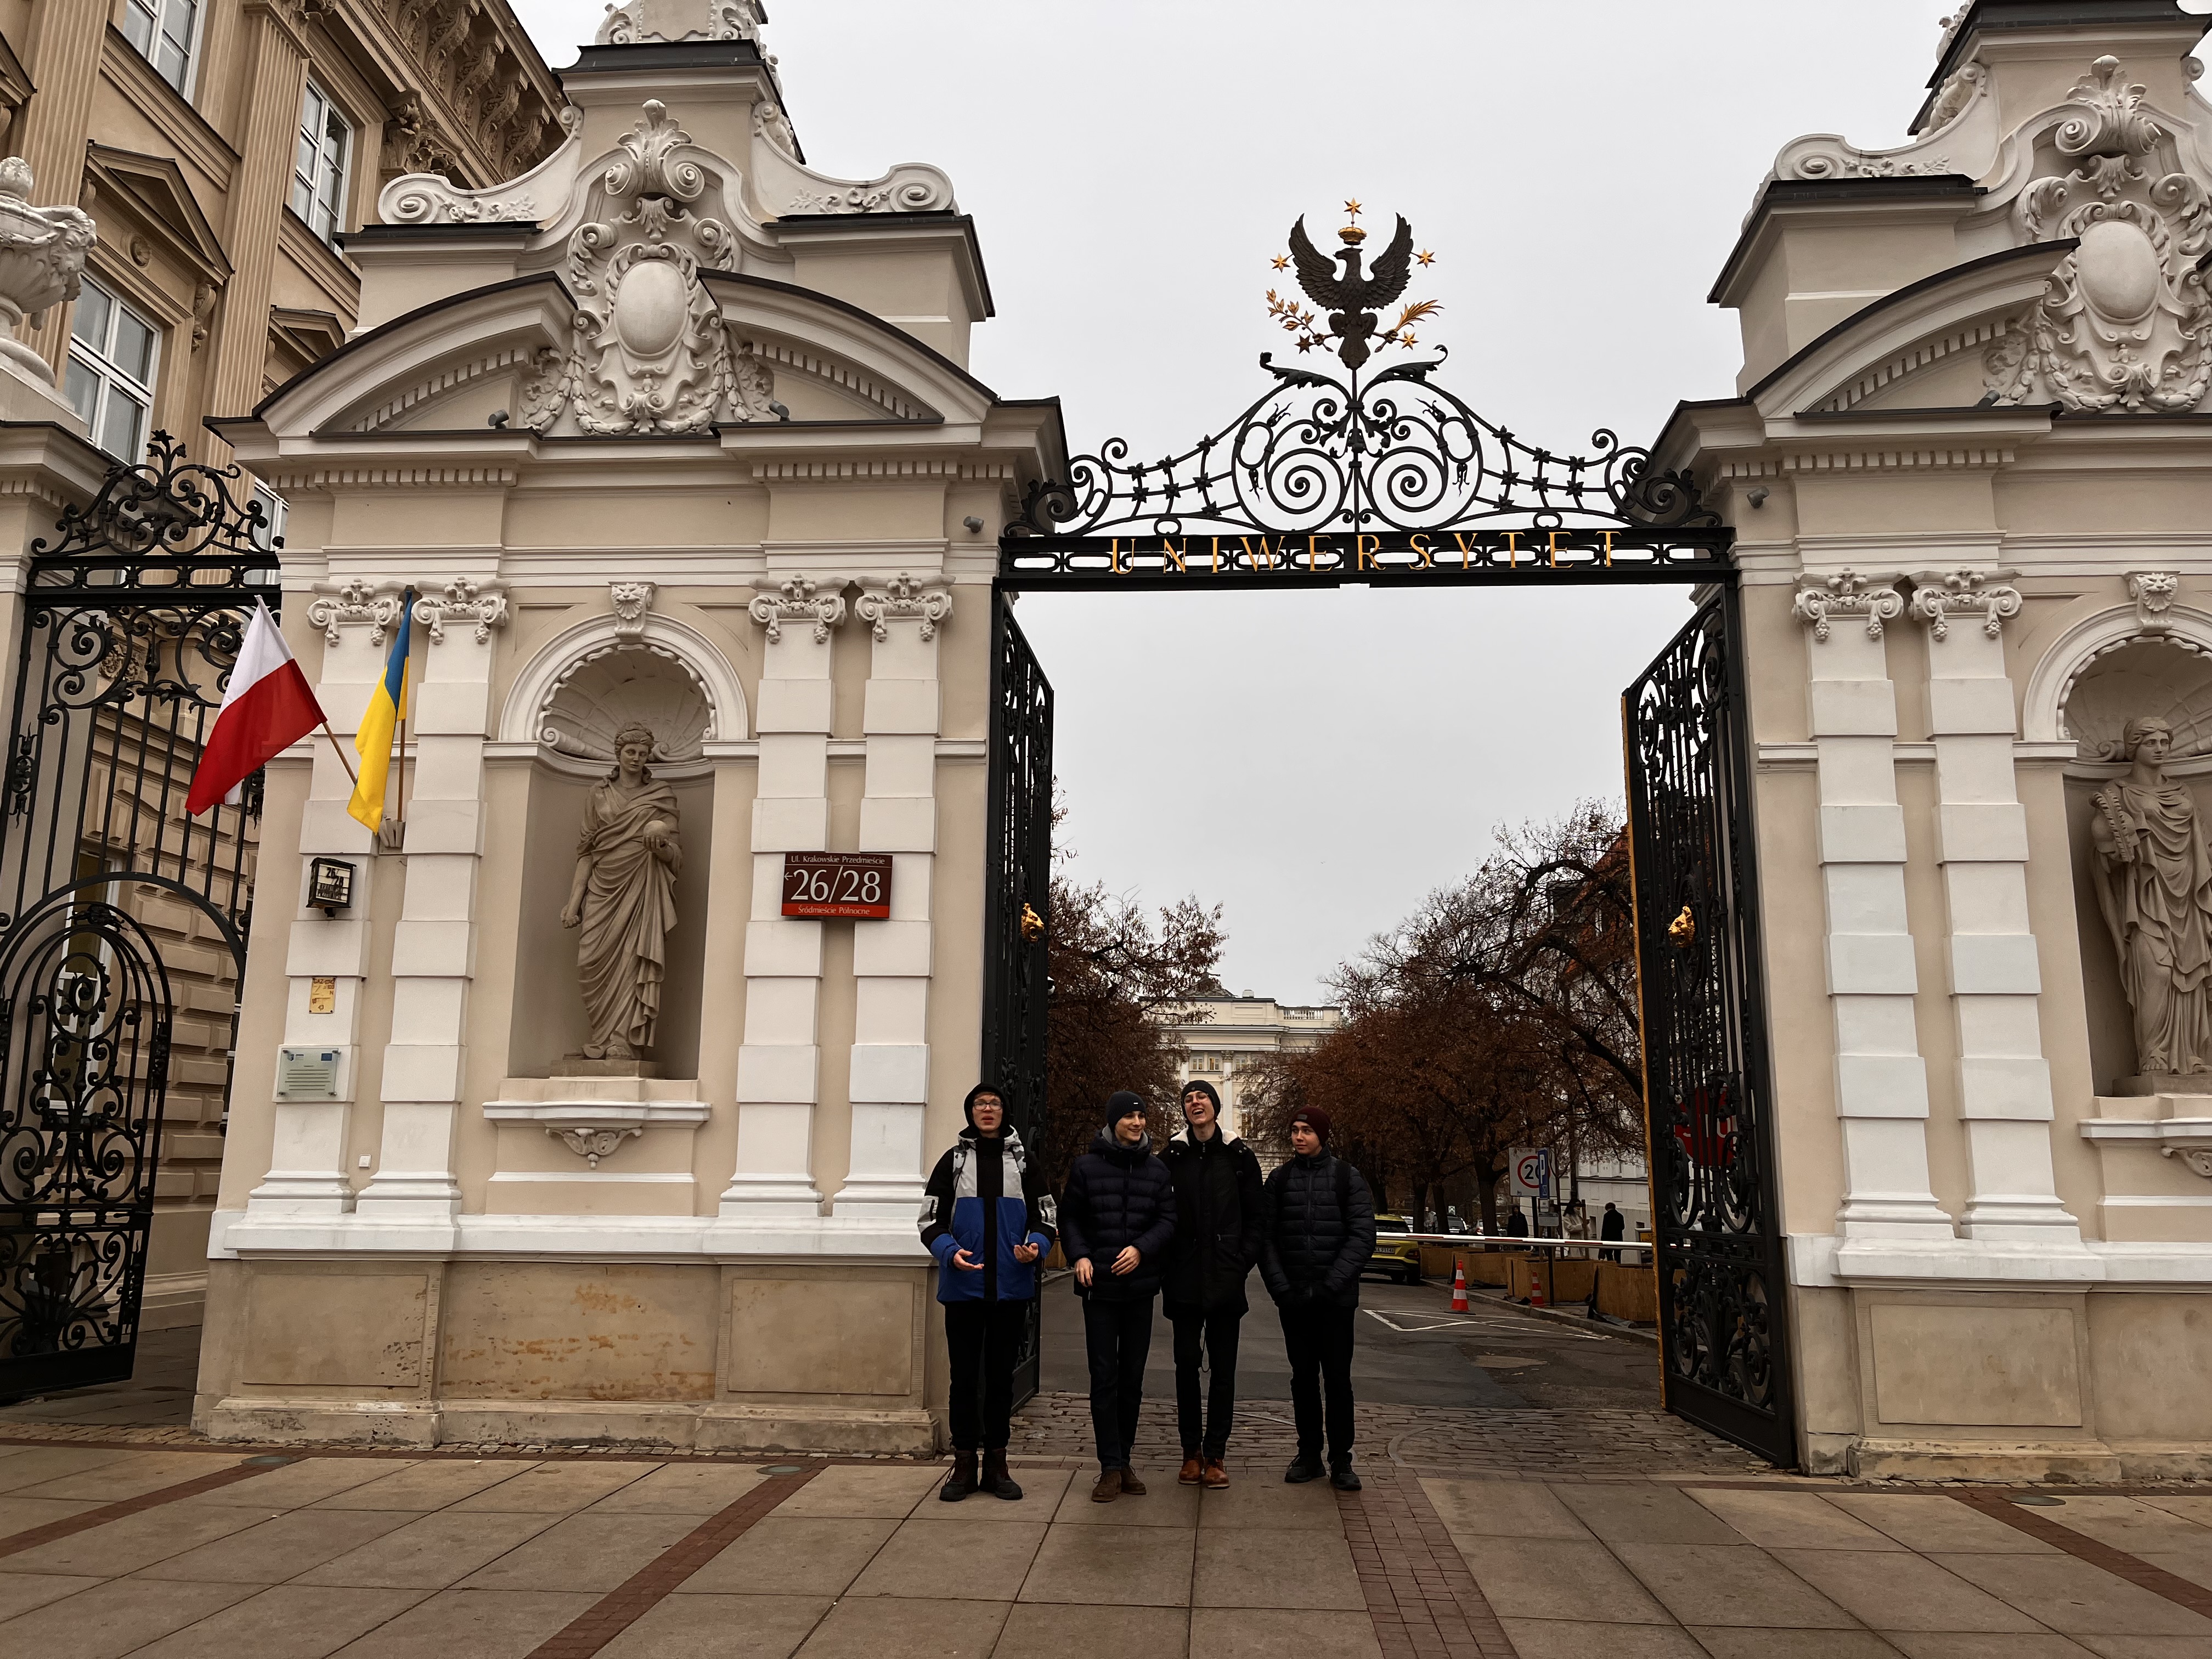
[1159,1080,1261,1489]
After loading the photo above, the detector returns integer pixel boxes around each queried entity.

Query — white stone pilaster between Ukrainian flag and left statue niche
[358,579,506,1223]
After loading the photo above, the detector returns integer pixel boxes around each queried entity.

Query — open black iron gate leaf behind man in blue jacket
[982,591,1053,1404]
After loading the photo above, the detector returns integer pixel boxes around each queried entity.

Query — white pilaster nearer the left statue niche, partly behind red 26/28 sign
[721,577,845,1221]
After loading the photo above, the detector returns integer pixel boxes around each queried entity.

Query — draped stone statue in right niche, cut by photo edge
[2088,716,2212,1093]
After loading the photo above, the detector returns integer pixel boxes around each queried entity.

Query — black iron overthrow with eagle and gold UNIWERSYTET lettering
[1000,201,1730,589]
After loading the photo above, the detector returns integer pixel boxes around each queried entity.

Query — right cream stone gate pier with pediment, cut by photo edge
[1657,0,2212,1477]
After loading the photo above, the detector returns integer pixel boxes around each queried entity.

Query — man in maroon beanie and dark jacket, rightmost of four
[1259,1106,1376,1491]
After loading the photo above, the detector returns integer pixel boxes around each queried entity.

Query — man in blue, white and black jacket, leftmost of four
[922,1084,1055,1504]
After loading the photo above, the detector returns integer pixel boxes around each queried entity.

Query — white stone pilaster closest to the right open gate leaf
[1794,571,1953,1239]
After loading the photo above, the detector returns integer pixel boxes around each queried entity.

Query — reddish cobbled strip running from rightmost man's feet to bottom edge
[1336,1466,1520,1659]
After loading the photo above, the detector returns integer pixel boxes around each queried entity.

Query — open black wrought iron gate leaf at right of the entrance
[1623,584,1796,1466]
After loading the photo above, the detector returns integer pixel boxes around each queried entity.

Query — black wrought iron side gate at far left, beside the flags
[0,433,279,1400]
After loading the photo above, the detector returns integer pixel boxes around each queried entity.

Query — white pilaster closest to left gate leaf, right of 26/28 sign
[832,575,953,1226]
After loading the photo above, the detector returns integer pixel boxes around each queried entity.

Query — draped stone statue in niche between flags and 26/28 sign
[560,723,684,1059]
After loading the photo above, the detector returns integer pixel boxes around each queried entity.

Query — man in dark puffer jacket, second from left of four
[1059,1088,1175,1504]
